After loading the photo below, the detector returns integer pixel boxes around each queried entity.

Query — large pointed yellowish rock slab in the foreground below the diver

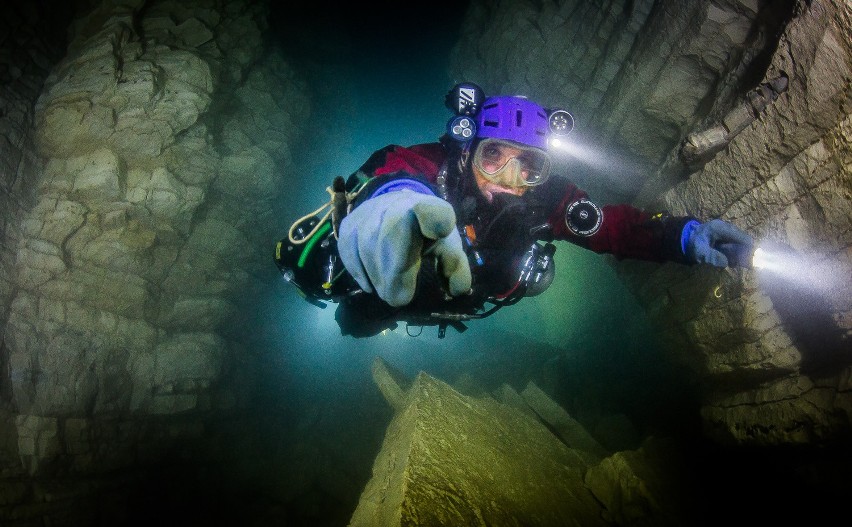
[349,373,607,527]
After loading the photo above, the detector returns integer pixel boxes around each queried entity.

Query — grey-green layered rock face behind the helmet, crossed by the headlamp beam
[451,0,792,201]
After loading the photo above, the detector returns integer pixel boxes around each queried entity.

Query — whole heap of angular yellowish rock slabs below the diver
[349,359,678,527]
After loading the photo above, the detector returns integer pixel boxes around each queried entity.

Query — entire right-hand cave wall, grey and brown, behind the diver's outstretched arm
[452,1,852,445]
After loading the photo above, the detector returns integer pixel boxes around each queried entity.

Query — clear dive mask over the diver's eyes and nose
[473,139,550,187]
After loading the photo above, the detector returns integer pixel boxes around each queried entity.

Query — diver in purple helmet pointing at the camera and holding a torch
[275,83,753,337]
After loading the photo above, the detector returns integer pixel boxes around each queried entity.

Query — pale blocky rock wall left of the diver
[0,0,309,522]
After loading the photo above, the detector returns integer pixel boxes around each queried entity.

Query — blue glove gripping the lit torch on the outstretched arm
[681,220,754,267]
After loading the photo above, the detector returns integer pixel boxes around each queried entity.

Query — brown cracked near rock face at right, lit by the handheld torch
[622,2,852,445]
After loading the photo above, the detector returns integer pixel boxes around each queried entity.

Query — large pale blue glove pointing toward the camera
[337,186,471,307]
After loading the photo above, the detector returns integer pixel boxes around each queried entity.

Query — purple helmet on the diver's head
[476,95,549,150]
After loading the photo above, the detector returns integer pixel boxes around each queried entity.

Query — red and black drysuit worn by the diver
[337,143,693,336]
